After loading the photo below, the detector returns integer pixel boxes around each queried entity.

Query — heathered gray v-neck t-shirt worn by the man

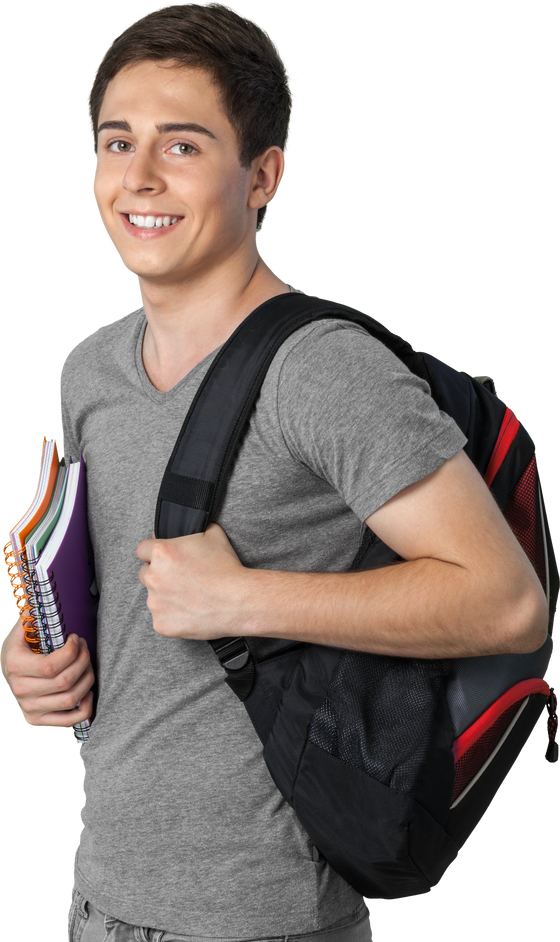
[59,292,467,942]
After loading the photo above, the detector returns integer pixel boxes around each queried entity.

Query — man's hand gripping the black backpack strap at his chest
[136,523,251,641]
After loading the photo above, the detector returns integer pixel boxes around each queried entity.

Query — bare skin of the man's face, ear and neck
[92,62,289,389]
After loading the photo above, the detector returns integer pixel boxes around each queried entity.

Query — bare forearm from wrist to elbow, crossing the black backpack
[246,558,546,658]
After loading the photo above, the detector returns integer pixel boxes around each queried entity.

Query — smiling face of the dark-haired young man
[92,62,279,286]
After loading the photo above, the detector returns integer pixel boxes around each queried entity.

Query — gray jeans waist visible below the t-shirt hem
[66,886,373,942]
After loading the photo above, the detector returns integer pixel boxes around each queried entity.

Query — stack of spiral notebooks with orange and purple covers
[2,435,99,745]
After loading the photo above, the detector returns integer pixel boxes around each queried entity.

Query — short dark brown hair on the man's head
[87,0,293,233]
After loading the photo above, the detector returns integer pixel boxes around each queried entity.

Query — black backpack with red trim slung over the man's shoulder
[154,293,560,899]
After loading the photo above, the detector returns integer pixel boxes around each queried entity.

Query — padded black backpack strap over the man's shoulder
[154,294,404,539]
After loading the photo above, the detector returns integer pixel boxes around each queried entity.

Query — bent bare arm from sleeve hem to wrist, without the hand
[244,450,548,658]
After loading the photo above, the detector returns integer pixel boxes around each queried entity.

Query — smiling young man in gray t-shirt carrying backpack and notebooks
[2,4,547,942]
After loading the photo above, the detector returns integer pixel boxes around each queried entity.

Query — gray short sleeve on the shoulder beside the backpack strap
[278,319,468,522]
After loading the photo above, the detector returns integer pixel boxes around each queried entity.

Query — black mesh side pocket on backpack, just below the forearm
[309,651,450,792]
